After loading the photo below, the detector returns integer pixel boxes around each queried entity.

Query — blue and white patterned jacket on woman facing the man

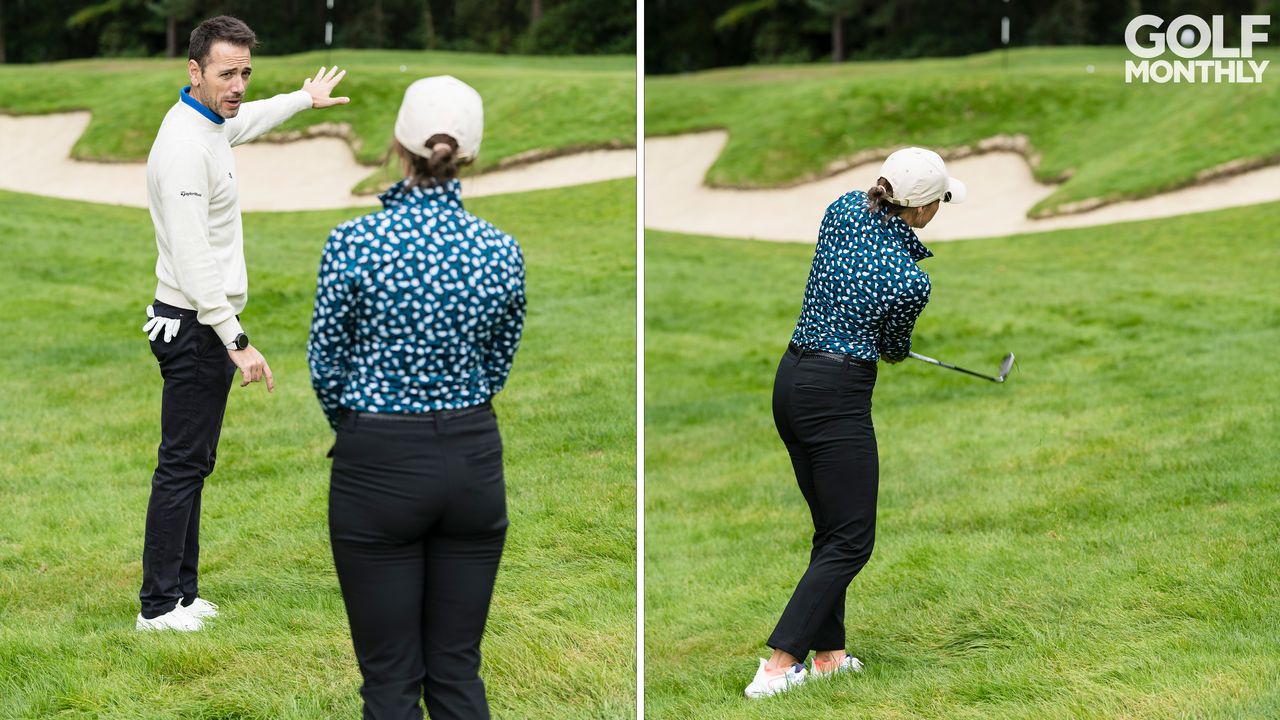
[307,179,525,427]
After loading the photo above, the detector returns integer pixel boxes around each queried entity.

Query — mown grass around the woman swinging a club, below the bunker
[645,204,1280,720]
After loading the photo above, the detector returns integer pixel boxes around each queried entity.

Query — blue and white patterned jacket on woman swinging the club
[791,190,933,363]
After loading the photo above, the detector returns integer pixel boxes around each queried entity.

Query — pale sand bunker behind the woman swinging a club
[644,131,1280,242]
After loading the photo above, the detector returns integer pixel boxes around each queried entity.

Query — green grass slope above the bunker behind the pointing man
[0,50,635,190]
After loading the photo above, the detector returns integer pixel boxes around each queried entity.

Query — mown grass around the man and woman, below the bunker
[0,181,635,720]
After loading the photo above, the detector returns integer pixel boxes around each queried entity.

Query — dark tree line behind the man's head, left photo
[0,0,636,63]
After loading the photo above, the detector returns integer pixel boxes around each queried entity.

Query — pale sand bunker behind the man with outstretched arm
[0,113,636,210]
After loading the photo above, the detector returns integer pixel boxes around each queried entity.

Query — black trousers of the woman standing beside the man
[329,404,507,720]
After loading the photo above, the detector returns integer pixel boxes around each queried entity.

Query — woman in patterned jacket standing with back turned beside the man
[307,77,525,720]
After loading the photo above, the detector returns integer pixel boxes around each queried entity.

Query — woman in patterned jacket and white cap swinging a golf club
[746,147,965,698]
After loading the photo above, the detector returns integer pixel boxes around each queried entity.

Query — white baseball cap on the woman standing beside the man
[396,76,484,163]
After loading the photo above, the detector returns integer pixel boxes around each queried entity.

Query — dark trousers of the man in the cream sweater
[138,300,236,619]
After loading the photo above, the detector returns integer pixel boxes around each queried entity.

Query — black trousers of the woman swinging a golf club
[769,348,879,660]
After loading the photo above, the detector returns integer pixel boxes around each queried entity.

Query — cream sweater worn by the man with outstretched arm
[147,87,311,343]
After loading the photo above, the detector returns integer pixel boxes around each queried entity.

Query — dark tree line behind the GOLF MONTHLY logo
[645,0,1280,73]
